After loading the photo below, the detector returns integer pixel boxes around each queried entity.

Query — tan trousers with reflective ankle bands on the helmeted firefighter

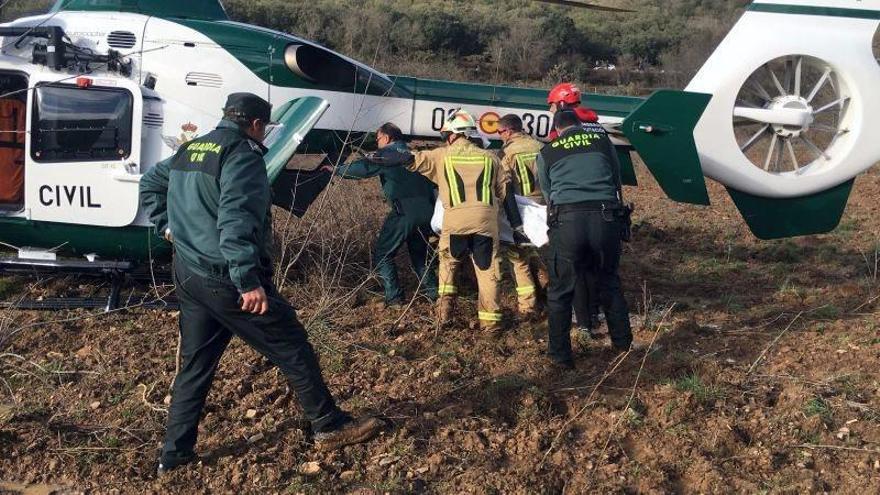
[438,234,502,328]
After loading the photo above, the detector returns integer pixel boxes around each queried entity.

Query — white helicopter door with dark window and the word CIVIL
[25,77,143,227]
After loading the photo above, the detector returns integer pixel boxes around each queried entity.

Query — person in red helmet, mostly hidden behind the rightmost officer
[547,83,603,340]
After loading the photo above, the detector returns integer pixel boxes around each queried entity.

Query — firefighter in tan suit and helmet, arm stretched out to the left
[385,110,508,332]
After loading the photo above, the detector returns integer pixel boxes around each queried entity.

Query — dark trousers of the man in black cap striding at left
[161,261,348,465]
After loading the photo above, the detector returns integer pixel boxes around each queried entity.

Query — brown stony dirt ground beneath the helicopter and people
[0,165,880,494]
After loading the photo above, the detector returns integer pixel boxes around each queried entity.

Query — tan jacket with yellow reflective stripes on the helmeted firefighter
[409,138,507,239]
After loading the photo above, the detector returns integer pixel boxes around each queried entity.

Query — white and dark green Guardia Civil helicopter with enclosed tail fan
[0,0,880,290]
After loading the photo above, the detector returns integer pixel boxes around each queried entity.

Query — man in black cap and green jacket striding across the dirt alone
[140,93,382,475]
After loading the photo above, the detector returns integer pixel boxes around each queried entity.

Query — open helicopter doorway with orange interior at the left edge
[0,72,28,213]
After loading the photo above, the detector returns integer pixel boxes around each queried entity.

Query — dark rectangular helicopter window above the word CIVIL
[31,85,134,162]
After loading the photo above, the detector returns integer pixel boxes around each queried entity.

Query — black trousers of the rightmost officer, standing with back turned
[547,205,632,361]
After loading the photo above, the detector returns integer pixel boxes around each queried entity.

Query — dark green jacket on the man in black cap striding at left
[140,120,272,293]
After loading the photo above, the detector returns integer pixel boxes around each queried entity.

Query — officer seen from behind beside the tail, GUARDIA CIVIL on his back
[537,110,632,367]
